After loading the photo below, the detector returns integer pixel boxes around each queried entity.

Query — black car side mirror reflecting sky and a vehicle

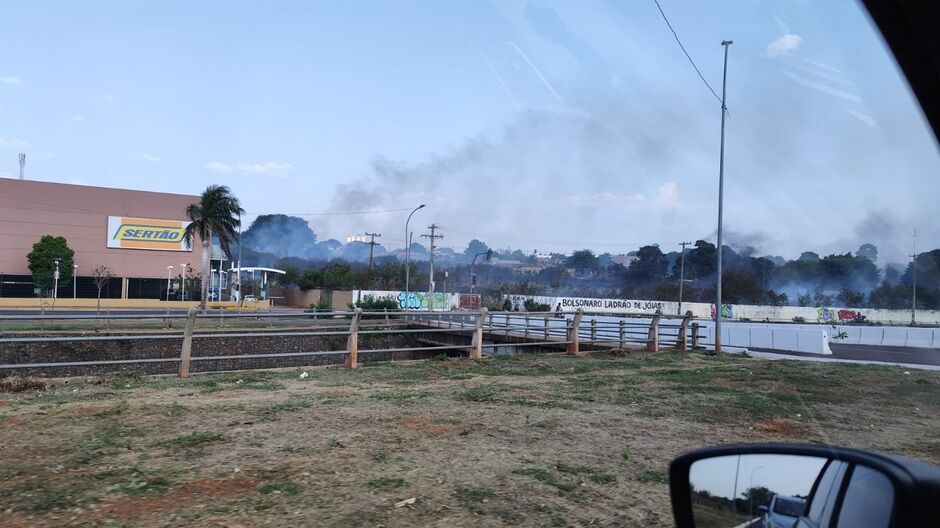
[669,444,940,528]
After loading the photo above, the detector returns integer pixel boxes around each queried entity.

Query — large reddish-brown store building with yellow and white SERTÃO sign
[0,178,202,299]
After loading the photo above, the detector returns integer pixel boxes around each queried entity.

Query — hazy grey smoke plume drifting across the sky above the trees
[302,2,940,264]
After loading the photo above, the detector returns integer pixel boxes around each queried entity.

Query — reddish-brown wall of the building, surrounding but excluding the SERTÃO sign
[0,178,202,279]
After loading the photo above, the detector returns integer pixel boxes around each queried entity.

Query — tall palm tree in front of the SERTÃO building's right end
[183,185,245,311]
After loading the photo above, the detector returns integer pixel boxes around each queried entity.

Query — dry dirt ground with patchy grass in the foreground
[0,353,940,527]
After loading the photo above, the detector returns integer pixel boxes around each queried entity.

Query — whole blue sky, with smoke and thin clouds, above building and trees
[0,0,940,265]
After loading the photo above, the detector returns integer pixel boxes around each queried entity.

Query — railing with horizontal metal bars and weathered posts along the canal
[0,308,698,377]
